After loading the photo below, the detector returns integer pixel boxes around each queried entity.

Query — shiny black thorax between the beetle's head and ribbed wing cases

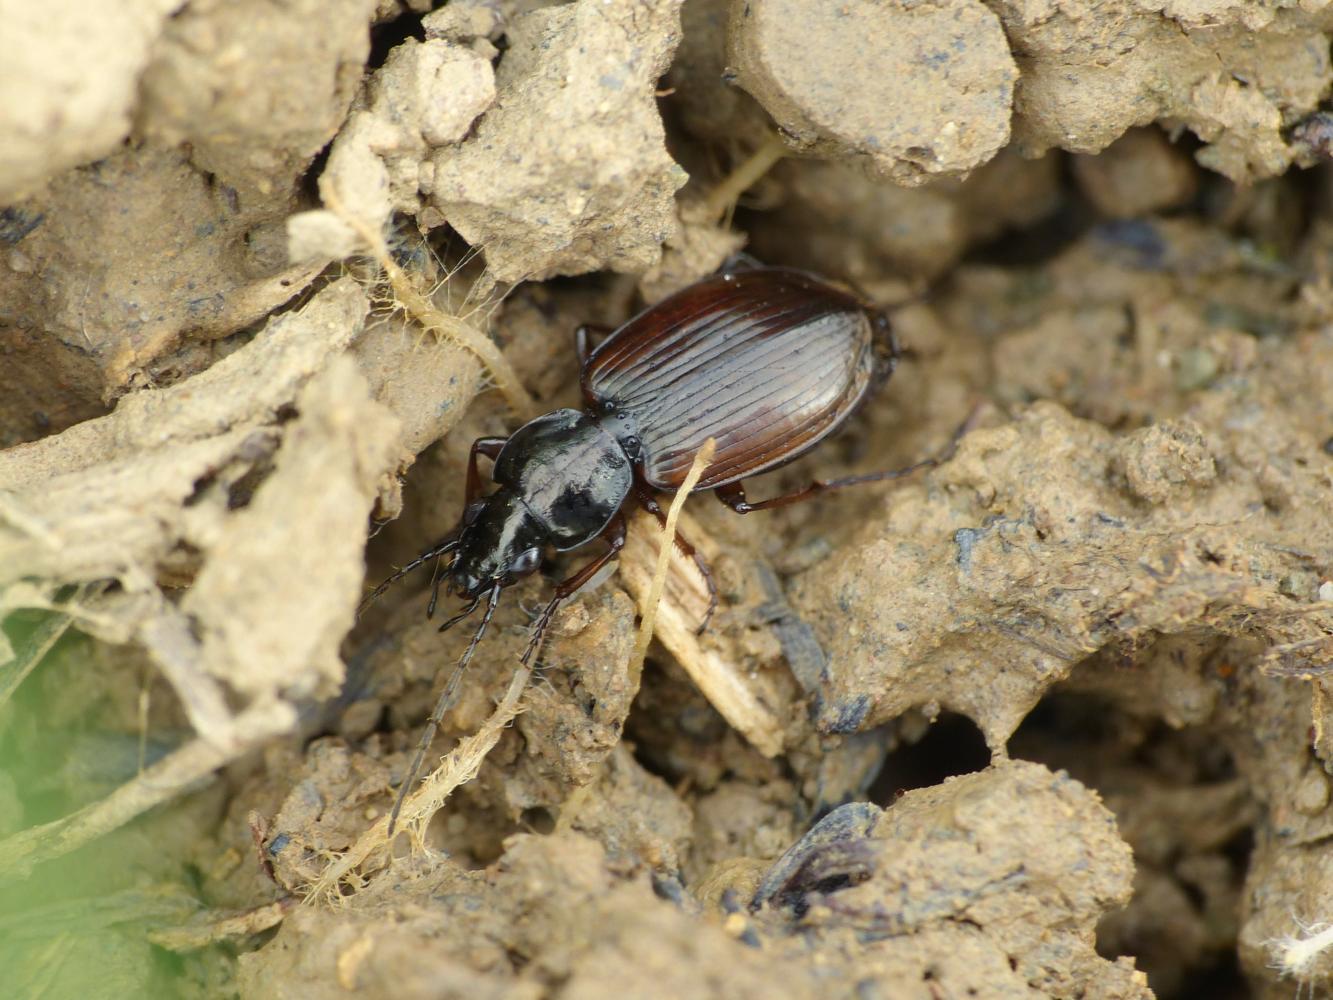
[491,409,635,552]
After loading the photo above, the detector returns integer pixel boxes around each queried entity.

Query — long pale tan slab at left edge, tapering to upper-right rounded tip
[0,280,368,589]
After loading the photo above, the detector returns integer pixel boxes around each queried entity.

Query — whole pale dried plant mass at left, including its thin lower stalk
[0,281,399,867]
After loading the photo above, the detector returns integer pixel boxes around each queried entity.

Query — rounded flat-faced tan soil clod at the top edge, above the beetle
[728,0,1018,184]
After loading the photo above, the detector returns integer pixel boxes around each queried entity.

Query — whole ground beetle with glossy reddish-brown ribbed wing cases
[368,267,959,829]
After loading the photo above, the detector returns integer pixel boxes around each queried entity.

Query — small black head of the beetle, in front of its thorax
[448,488,548,597]
